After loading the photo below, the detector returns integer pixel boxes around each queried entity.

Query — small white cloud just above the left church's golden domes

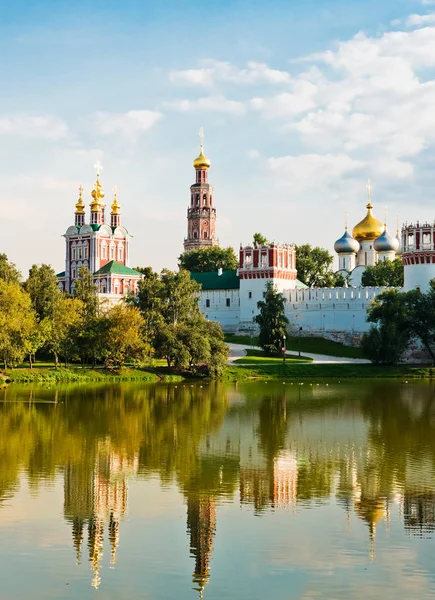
[93,110,163,138]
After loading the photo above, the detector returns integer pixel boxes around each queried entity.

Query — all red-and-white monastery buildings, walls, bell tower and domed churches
[58,136,435,343]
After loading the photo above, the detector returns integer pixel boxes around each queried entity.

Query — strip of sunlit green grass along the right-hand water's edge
[225,361,435,381]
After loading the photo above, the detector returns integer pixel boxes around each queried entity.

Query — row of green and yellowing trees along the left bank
[0,254,228,376]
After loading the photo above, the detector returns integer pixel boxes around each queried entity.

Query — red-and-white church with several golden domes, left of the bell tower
[57,163,142,302]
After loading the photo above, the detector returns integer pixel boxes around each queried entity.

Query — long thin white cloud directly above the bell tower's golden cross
[169,59,291,87]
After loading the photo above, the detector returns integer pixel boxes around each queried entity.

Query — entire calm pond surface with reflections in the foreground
[0,381,435,600]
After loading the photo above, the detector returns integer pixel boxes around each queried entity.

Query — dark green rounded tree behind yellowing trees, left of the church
[24,265,60,320]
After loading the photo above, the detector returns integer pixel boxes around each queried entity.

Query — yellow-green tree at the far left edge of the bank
[0,279,36,369]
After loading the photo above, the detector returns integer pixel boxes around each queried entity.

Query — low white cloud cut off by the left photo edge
[0,115,68,141]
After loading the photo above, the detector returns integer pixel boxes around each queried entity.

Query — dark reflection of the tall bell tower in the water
[187,495,216,598]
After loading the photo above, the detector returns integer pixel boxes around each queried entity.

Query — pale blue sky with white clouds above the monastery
[0,0,435,275]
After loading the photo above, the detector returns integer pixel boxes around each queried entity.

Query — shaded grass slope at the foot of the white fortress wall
[225,334,363,358]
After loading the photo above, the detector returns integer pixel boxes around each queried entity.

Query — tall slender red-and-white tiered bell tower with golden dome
[184,127,219,252]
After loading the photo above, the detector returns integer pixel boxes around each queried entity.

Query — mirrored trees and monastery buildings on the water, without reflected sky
[0,382,435,597]
